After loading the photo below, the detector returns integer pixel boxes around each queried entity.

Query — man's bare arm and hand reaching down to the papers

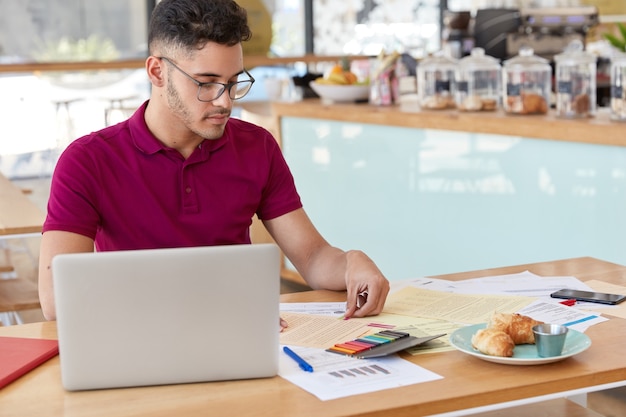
[263,209,389,317]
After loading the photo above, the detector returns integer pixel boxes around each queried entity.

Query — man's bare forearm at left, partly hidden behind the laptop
[39,230,94,320]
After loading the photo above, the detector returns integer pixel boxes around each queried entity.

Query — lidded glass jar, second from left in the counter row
[454,48,502,111]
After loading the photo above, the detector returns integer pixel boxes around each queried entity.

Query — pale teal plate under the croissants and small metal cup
[450,323,591,365]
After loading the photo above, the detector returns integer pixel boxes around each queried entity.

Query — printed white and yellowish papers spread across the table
[279,271,626,400]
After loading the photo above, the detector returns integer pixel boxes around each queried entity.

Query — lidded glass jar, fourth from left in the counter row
[554,40,597,118]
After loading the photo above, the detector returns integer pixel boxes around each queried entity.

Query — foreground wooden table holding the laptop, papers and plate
[0,258,626,417]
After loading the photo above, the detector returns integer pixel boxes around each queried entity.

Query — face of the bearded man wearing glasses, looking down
[163,43,246,139]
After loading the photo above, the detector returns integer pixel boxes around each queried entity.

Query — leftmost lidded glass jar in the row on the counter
[417,55,458,110]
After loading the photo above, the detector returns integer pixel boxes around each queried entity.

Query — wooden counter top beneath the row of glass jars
[270,98,626,146]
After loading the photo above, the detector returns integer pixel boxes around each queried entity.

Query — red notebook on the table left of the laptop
[0,337,59,388]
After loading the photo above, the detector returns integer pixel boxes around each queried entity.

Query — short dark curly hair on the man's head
[148,0,252,54]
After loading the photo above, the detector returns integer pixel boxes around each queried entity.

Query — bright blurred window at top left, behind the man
[0,0,148,63]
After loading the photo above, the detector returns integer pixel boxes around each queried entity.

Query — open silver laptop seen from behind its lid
[52,244,280,390]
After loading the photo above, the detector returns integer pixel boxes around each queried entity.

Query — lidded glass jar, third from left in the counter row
[502,47,552,114]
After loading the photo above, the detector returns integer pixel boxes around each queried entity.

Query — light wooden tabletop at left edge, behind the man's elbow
[0,174,46,238]
